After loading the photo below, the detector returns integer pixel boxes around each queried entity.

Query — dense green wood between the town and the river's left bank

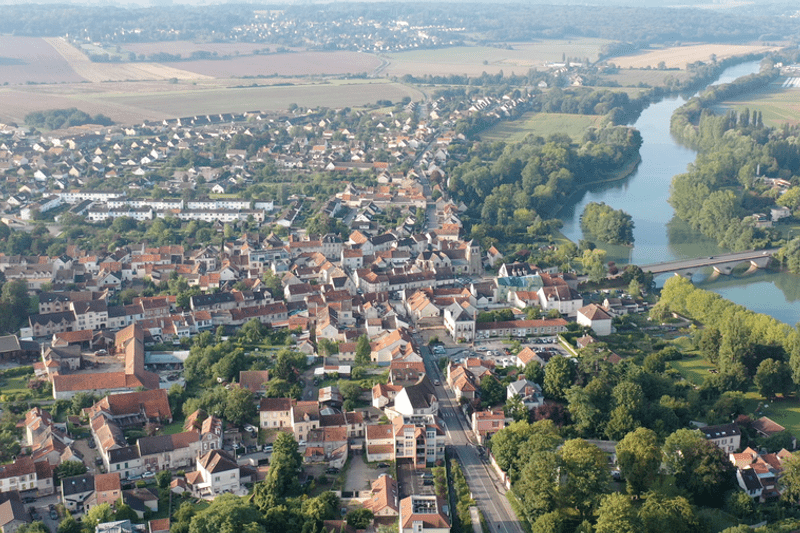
[447,126,642,255]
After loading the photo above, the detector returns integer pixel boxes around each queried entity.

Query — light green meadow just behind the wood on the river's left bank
[481,112,604,142]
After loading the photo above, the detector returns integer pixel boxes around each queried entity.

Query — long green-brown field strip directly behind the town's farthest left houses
[0,80,422,124]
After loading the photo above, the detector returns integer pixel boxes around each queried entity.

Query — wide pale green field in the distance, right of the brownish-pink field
[381,39,609,76]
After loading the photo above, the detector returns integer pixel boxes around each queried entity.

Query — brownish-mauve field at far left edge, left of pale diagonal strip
[0,35,84,85]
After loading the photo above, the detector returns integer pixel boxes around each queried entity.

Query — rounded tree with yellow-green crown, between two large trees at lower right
[616,428,661,496]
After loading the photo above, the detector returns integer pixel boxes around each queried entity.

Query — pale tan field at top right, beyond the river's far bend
[608,44,780,69]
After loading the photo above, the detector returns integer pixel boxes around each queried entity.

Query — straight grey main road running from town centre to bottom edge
[414,333,524,533]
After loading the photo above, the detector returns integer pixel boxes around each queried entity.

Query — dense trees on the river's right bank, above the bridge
[669,55,800,254]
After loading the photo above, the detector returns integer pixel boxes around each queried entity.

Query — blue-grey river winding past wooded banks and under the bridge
[557,61,800,325]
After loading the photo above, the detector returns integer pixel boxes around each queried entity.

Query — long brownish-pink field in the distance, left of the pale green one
[163,52,381,78]
